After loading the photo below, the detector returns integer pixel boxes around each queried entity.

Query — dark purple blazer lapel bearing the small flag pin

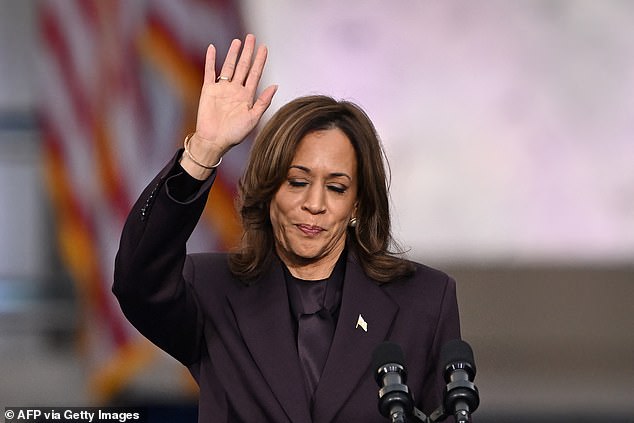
[313,256,398,423]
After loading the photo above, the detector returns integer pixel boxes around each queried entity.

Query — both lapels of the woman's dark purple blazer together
[229,254,398,423]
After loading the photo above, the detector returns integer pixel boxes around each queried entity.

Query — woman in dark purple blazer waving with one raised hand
[113,35,460,422]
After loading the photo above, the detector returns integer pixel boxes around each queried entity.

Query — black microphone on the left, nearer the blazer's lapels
[372,342,414,423]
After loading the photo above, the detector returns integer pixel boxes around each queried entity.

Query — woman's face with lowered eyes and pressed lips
[269,128,357,278]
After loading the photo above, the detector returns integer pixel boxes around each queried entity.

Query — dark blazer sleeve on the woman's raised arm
[112,150,216,365]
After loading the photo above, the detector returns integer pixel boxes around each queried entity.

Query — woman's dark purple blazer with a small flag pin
[113,155,460,423]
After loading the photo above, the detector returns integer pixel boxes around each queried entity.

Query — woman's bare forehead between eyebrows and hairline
[291,128,357,176]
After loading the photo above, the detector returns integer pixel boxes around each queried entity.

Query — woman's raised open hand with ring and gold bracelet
[181,34,277,179]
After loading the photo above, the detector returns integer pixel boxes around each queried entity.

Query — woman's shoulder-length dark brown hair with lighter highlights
[229,95,414,282]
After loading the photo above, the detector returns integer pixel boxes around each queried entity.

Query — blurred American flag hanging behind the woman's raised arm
[37,0,243,402]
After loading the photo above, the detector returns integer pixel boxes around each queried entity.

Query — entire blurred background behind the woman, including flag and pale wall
[0,0,634,422]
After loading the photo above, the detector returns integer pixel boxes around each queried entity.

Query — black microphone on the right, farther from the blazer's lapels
[440,339,480,423]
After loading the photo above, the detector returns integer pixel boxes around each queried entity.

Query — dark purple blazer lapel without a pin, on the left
[229,262,310,422]
